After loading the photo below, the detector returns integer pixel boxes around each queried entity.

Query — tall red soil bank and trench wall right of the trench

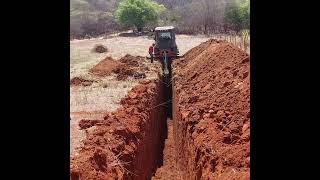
[173,40,250,180]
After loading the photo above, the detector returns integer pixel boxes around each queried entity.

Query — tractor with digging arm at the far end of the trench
[149,26,179,77]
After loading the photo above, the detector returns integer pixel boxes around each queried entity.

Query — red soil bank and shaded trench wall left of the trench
[70,80,166,179]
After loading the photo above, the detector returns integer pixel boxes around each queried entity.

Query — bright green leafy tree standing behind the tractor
[115,0,166,32]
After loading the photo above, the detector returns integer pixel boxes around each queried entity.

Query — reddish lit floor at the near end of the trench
[151,118,182,180]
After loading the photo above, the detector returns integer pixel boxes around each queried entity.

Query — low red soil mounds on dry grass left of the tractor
[90,54,149,81]
